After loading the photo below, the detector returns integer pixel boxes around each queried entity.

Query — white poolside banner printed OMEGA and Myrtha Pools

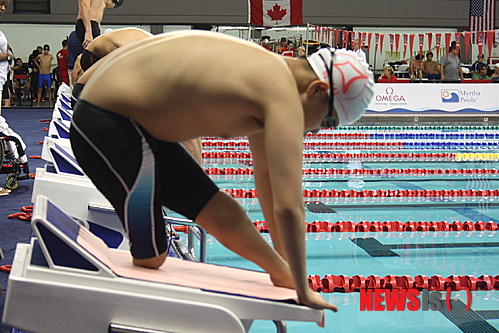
[367,83,499,113]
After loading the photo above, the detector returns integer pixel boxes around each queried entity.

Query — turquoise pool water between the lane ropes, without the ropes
[174,127,499,333]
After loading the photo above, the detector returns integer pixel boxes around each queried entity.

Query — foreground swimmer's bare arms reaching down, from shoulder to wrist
[250,104,309,290]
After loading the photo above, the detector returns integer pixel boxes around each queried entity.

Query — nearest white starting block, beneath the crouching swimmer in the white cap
[3,196,324,333]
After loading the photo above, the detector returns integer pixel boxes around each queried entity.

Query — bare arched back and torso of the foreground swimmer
[81,31,303,141]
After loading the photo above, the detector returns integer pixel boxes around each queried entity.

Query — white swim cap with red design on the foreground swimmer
[307,48,374,126]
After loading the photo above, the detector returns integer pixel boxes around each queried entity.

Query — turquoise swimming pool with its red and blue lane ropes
[176,126,499,333]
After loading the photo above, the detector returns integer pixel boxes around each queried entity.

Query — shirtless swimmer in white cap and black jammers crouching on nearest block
[71,31,373,311]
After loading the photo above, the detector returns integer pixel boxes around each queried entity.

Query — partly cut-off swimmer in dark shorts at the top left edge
[75,0,124,48]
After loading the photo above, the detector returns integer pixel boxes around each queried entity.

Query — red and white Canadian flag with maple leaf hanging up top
[249,0,303,27]
